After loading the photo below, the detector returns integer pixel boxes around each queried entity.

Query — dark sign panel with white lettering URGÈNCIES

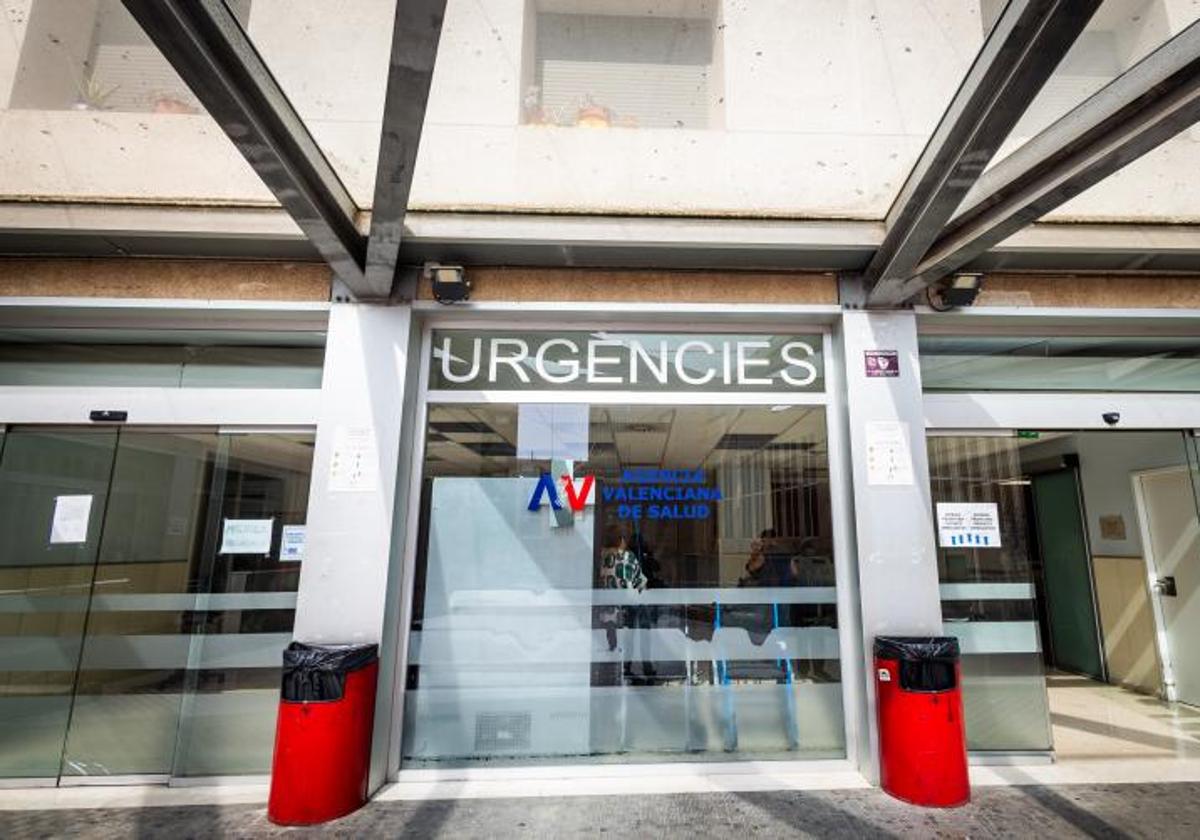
[430,330,824,391]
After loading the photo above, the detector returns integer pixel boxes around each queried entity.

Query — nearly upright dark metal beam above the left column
[359,0,446,298]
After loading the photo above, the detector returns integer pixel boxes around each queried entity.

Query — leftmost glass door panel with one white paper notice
[0,428,116,778]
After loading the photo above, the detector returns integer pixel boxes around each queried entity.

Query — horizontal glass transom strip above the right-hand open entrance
[920,335,1200,391]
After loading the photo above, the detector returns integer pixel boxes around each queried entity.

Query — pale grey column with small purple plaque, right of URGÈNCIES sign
[840,311,942,782]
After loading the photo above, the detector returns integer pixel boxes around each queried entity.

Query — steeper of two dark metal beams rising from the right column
[865,0,1100,307]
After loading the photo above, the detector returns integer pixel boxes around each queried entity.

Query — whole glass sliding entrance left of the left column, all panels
[0,427,312,779]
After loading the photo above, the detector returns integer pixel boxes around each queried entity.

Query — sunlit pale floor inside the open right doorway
[1046,674,1200,762]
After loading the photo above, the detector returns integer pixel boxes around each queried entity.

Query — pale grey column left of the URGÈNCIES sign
[294,304,420,791]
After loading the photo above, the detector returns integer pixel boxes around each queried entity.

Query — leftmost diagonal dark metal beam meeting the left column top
[122,0,367,289]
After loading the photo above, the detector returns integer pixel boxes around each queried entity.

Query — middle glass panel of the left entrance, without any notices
[62,430,218,776]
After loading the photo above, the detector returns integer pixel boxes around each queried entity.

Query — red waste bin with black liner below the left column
[266,642,379,826]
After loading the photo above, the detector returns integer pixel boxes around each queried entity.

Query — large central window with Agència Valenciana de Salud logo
[403,404,845,762]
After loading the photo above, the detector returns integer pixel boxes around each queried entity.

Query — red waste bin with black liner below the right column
[875,636,971,808]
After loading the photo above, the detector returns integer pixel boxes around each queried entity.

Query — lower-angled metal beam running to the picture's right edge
[900,23,1200,295]
